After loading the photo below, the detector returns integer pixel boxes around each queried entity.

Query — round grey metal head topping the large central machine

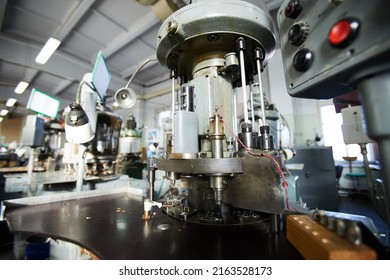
[157,0,276,77]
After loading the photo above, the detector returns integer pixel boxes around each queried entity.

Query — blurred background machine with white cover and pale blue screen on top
[63,53,122,189]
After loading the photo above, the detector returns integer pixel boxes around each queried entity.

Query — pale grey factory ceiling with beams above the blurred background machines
[0,0,282,117]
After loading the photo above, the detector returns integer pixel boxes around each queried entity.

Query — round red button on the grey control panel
[328,19,359,47]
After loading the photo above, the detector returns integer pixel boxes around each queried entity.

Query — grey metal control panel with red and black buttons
[277,0,390,99]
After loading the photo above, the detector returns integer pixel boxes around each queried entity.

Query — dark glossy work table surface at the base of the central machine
[1,191,302,260]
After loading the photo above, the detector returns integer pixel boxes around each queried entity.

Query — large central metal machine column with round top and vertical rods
[139,0,289,231]
